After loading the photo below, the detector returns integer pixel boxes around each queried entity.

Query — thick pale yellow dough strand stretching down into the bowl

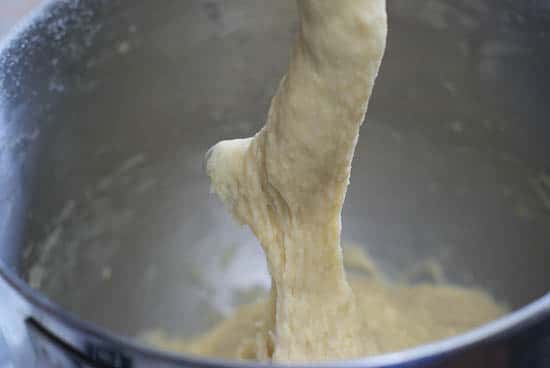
[206,0,387,362]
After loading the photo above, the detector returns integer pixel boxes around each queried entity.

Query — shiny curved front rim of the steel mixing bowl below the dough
[0,261,550,368]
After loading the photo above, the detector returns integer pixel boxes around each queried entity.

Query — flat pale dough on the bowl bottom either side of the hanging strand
[143,247,506,361]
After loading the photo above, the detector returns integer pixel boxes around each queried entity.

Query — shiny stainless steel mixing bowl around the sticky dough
[0,0,550,367]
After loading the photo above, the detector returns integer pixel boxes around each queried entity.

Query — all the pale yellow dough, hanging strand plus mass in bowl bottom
[150,0,504,363]
